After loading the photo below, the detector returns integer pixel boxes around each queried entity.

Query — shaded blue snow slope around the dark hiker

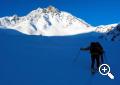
[0,30,120,85]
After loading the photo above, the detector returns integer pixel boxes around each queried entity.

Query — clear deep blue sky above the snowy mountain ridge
[0,0,120,26]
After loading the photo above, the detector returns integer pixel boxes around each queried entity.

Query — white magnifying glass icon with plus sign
[99,64,114,79]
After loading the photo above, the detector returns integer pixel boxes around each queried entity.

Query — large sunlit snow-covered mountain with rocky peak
[0,6,94,36]
